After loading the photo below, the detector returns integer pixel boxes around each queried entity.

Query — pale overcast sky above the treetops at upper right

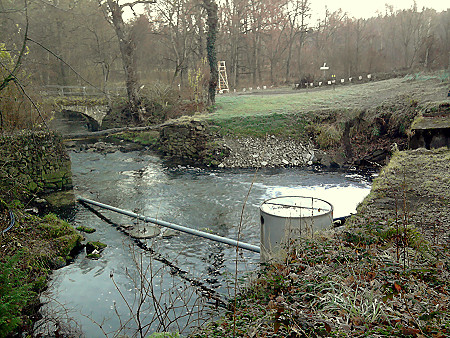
[310,0,450,18]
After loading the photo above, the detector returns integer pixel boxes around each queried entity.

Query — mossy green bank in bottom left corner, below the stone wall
[0,202,82,337]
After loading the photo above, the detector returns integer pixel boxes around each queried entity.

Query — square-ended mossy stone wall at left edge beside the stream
[0,132,72,198]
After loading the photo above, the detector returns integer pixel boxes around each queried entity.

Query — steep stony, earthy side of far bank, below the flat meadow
[105,97,449,170]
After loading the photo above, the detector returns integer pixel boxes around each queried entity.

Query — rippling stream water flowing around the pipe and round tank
[38,152,370,337]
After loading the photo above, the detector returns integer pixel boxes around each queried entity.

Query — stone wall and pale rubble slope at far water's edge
[159,119,314,168]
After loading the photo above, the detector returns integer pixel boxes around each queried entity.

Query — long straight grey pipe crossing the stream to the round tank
[77,196,261,252]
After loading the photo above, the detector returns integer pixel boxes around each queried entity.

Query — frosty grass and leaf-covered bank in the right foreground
[192,149,450,338]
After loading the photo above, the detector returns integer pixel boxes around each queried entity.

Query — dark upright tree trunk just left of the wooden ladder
[203,0,219,105]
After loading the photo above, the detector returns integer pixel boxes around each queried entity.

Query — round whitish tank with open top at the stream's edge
[260,196,333,263]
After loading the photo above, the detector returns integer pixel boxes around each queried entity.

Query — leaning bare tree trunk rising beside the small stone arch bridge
[107,0,144,123]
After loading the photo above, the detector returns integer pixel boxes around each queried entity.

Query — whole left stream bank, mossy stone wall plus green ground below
[0,132,83,337]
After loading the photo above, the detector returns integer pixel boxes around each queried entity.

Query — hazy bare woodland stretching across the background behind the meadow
[0,0,450,103]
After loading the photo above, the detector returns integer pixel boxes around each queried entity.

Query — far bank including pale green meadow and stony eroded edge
[60,76,448,169]
